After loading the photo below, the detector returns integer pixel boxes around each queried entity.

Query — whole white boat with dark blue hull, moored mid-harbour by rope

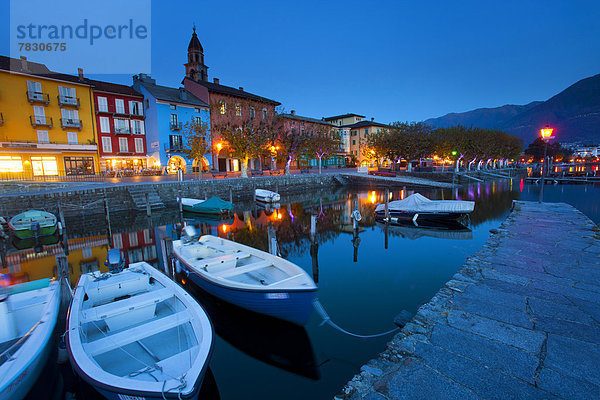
[173,230,317,325]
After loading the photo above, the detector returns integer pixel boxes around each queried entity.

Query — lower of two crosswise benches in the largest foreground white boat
[83,311,190,357]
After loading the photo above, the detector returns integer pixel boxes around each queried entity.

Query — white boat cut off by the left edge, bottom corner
[0,279,60,400]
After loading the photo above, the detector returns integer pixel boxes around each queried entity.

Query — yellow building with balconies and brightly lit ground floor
[0,56,99,178]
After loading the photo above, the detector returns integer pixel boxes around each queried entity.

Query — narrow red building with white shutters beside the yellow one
[90,80,147,173]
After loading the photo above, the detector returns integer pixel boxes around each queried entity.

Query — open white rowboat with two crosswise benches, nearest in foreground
[67,260,213,399]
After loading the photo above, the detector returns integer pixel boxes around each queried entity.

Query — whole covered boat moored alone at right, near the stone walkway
[375,193,475,225]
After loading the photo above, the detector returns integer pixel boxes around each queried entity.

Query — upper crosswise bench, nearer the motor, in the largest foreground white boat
[80,288,173,324]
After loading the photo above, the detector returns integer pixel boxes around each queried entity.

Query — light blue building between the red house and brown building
[133,74,212,174]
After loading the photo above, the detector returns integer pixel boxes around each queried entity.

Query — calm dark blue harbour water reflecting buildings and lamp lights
[8,181,600,399]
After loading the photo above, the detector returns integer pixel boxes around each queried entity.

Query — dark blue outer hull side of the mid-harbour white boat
[179,260,316,325]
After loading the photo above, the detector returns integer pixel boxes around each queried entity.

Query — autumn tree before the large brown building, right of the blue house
[213,118,271,178]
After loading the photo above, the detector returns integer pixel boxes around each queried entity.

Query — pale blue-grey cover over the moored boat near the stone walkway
[375,193,475,214]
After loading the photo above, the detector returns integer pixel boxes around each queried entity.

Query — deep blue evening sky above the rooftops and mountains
[0,0,600,122]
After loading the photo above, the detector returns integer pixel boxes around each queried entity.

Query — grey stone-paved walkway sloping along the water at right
[337,202,600,400]
